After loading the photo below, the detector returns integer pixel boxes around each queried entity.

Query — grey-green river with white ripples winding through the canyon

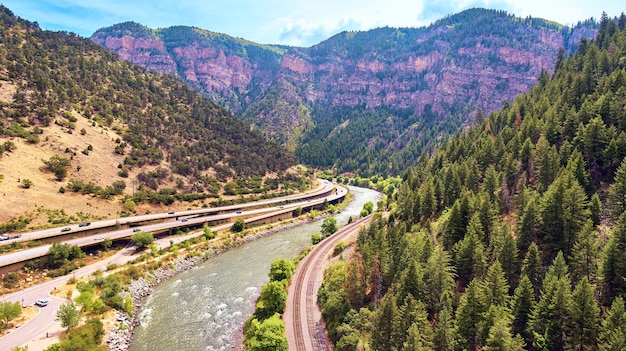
[130,187,380,351]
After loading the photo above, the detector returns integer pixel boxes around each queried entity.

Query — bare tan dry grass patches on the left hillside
[0,82,178,225]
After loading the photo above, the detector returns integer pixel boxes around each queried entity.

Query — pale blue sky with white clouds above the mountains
[0,0,626,46]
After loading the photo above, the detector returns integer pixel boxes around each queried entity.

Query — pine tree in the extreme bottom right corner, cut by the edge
[599,296,626,351]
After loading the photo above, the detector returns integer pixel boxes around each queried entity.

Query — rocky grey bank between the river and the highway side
[105,215,320,351]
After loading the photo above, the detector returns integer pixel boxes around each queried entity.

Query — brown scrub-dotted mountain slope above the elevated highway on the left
[0,7,295,223]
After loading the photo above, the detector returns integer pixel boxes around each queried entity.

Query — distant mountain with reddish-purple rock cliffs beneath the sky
[92,9,597,174]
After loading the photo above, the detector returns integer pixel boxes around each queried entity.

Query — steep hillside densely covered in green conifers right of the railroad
[319,14,626,351]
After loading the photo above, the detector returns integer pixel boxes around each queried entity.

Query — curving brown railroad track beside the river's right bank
[290,215,371,351]
